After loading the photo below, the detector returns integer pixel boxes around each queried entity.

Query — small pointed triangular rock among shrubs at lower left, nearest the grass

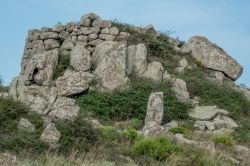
[40,123,61,145]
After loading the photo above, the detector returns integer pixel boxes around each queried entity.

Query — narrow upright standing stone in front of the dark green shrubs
[143,92,164,137]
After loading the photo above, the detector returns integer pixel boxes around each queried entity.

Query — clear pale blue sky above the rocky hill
[0,0,250,87]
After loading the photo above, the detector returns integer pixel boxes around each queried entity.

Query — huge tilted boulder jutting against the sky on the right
[184,36,243,80]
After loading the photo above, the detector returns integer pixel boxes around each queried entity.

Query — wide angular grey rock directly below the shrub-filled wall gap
[56,70,94,96]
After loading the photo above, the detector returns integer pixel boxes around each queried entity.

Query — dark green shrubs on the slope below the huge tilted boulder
[183,69,250,119]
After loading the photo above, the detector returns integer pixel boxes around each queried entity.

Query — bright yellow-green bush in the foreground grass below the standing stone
[130,138,177,160]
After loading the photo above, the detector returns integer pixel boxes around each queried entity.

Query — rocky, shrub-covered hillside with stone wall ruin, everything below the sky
[0,13,250,166]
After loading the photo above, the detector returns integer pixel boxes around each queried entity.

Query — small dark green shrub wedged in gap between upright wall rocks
[54,53,70,79]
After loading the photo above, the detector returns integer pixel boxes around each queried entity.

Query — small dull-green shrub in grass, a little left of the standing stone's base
[98,126,120,141]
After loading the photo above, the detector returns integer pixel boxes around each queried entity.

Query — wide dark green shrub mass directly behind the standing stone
[76,79,191,123]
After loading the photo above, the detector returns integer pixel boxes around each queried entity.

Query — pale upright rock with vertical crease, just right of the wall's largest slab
[128,44,147,77]
